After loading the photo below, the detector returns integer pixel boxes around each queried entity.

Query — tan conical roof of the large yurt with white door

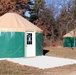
[0,13,42,32]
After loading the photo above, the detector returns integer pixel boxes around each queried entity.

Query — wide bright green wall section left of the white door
[0,32,24,58]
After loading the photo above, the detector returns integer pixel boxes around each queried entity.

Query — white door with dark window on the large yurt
[25,31,36,57]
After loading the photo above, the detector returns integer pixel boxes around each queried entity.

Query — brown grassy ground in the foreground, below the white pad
[0,60,76,75]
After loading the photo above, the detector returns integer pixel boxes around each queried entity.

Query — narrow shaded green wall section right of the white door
[36,33,43,56]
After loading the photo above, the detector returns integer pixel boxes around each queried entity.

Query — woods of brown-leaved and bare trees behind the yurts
[0,0,76,46]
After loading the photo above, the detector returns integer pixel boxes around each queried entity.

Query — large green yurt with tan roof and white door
[0,13,42,58]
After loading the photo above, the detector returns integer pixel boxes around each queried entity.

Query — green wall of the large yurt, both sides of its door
[0,32,43,58]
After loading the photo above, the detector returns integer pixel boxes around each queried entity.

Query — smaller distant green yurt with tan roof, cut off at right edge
[63,30,76,47]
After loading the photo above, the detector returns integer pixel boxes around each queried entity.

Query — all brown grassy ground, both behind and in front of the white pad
[0,47,76,75]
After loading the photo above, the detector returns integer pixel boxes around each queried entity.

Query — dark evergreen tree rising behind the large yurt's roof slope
[30,0,45,22]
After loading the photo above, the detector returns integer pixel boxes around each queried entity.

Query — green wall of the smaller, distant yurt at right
[64,37,76,47]
